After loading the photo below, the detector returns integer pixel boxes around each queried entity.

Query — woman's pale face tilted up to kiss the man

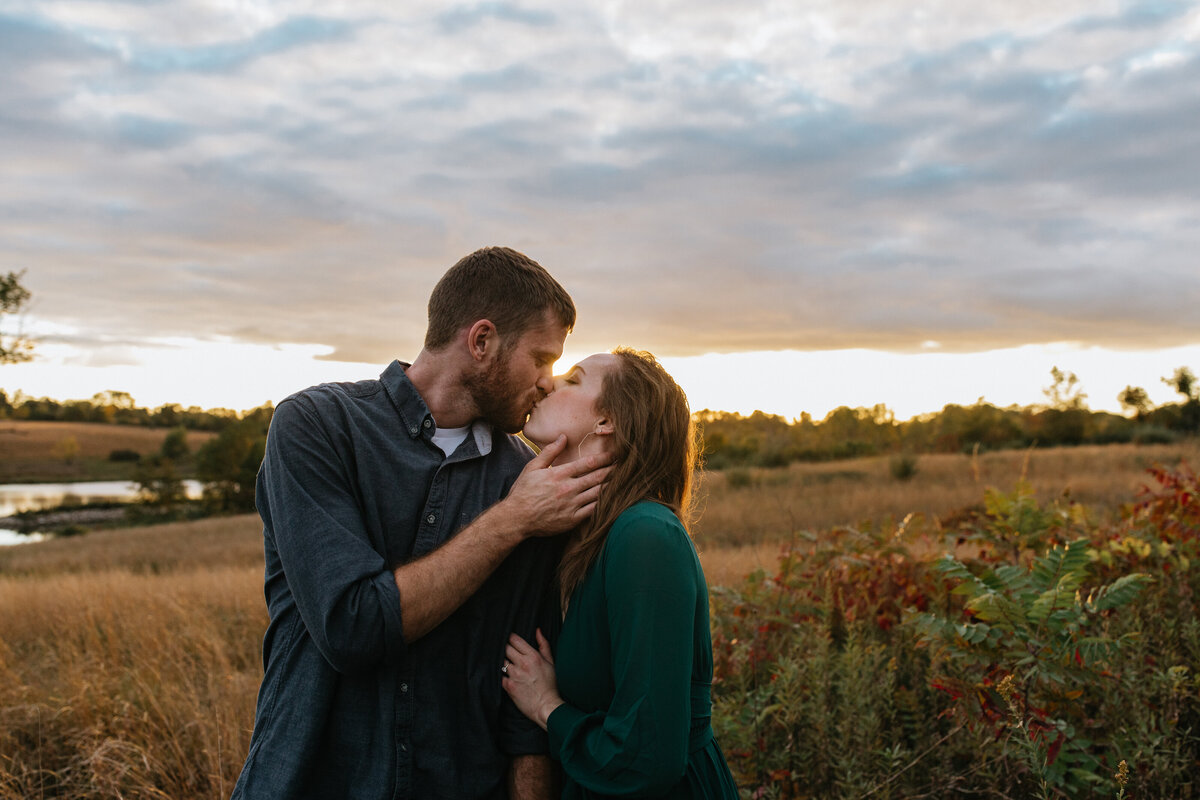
[524,353,618,461]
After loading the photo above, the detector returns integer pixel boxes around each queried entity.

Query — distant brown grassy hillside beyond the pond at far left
[0,420,215,483]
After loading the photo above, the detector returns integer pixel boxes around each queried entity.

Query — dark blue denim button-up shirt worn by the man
[233,362,559,800]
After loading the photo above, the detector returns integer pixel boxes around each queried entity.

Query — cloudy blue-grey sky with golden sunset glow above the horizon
[0,0,1200,419]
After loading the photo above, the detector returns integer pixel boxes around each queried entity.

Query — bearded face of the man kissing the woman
[467,311,566,433]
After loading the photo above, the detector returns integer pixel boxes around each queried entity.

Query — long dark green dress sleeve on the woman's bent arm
[548,516,697,795]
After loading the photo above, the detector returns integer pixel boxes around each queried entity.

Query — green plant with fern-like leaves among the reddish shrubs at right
[918,532,1151,798]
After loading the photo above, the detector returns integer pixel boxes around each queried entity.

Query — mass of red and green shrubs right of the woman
[712,468,1200,800]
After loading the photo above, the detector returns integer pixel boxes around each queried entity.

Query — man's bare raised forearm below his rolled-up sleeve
[394,501,524,644]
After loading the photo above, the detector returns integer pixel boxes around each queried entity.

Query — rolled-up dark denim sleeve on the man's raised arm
[258,399,404,673]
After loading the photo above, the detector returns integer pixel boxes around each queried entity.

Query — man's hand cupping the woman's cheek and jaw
[497,435,612,537]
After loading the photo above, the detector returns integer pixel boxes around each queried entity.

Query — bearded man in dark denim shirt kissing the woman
[233,247,606,800]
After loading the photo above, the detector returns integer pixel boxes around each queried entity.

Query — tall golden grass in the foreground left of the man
[0,567,266,799]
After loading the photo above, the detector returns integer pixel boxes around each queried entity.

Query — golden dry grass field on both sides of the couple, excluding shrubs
[0,441,1200,800]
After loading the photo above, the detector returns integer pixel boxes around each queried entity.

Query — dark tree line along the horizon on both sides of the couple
[0,367,1200,484]
